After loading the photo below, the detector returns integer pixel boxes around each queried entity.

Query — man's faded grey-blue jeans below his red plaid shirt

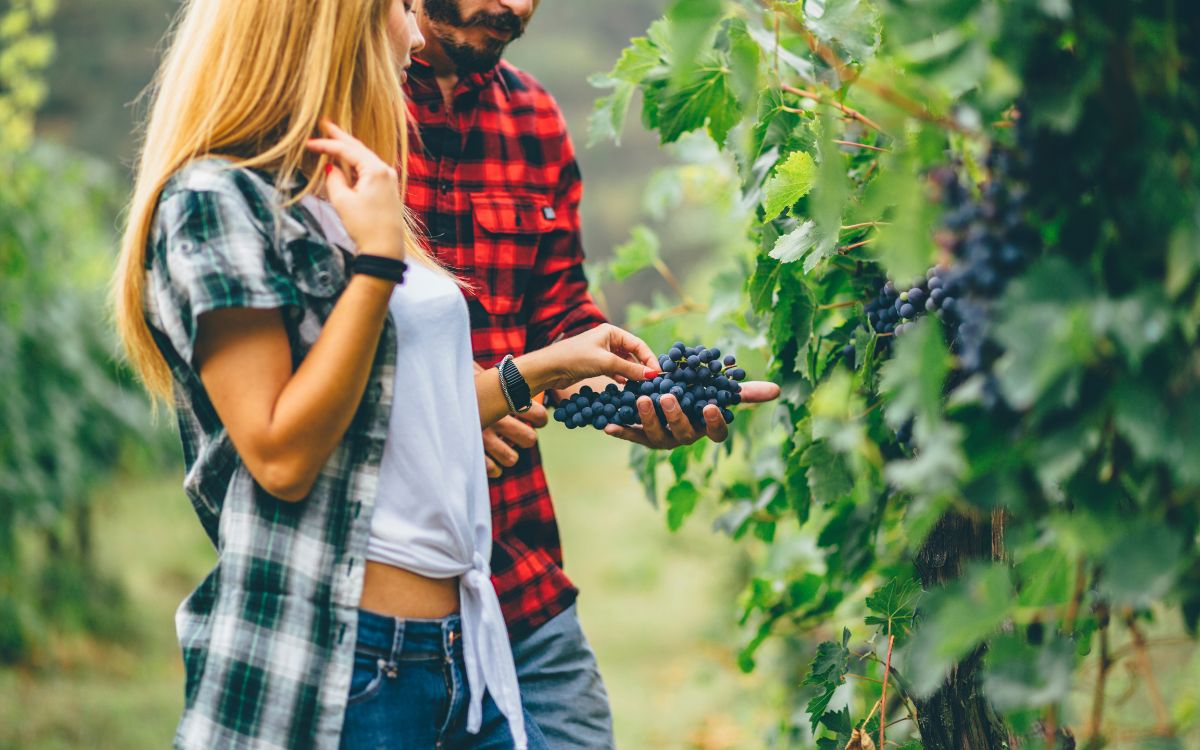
[512,605,617,750]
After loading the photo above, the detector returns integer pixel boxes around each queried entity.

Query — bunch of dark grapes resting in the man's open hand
[554,341,746,430]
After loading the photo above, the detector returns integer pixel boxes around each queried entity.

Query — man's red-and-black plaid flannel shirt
[406,60,605,638]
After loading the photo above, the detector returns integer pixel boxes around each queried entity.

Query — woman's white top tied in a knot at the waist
[301,197,527,750]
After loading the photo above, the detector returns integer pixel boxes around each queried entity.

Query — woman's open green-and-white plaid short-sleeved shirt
[146,158,396,750]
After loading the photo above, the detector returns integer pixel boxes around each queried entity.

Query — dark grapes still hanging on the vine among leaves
[866,134,1038,407]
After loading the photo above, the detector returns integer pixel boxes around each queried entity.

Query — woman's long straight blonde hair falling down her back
[113,0,436,402]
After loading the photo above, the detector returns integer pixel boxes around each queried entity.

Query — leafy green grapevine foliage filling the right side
[592,0,1200,748]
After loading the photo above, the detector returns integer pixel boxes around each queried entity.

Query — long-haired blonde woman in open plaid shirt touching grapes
[116,0,655,750]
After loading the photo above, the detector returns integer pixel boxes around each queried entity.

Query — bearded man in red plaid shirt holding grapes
[406,0,779,750]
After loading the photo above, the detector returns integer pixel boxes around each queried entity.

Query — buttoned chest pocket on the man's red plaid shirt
[470,191,556,316]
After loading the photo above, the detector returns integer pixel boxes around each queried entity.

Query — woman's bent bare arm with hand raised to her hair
[194,124,407,500]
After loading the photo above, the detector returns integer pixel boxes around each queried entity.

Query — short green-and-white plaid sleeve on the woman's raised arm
[148,174,301,364]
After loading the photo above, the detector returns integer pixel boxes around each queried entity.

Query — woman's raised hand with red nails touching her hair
[308,121,408,260]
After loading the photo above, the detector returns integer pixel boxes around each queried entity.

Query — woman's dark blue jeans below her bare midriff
[341,610,548,750]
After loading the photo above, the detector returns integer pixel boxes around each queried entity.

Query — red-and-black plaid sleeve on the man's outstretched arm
[526,114,607,350]
